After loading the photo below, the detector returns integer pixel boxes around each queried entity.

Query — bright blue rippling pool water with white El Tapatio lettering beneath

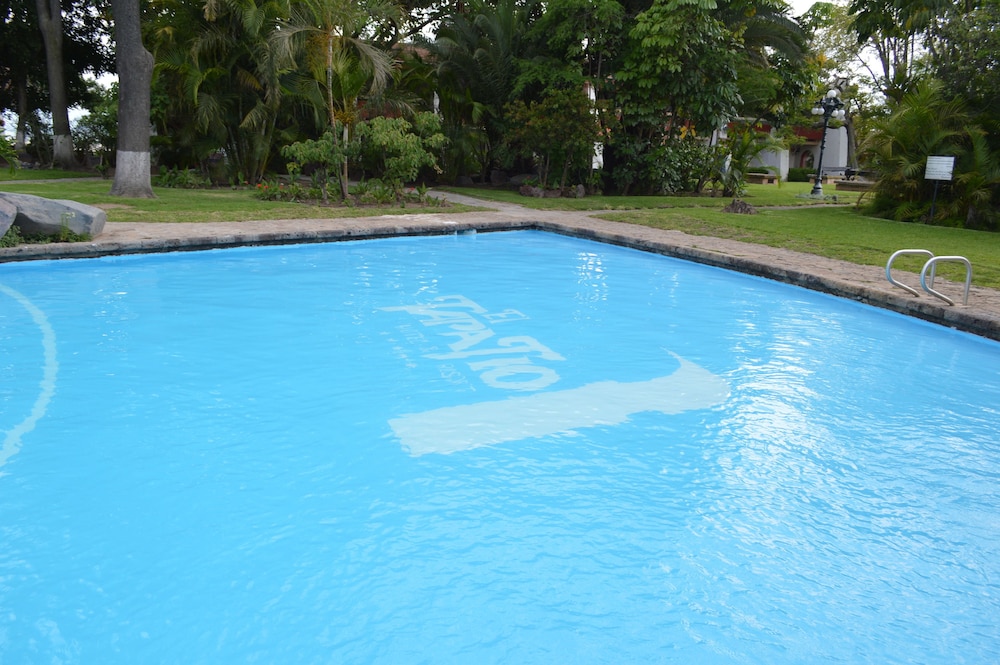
[0,232,1000,664]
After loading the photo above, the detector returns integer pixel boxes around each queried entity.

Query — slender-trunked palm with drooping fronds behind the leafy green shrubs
[271,0,400,198]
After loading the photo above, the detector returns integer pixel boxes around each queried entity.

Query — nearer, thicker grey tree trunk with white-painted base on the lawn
[111,0,154,199]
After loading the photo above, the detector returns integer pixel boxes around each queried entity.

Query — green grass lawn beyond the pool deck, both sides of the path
[0,171,1000,288]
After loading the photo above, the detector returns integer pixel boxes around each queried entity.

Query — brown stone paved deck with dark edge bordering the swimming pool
[0,193,1000,341]
